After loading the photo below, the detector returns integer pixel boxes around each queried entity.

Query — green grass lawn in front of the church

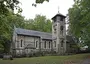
[0,53,90,64]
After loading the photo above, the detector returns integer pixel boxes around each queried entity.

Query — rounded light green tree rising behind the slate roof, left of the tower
[25,15,52,32]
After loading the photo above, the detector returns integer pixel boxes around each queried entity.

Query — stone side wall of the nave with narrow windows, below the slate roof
[14,35,52,55]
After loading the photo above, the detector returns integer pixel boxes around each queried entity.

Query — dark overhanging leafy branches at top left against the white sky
[0,0,49,15]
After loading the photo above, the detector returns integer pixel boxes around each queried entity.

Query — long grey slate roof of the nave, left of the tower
[15,28,52,40]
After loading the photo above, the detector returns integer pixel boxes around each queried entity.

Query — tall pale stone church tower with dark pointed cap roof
[52,12,66,55]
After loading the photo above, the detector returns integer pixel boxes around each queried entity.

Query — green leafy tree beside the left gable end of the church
[0,13,25,52]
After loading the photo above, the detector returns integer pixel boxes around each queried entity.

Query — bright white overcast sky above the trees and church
[19,0,74,19]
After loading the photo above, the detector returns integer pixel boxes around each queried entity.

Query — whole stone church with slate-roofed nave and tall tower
[11,13,76,55]
